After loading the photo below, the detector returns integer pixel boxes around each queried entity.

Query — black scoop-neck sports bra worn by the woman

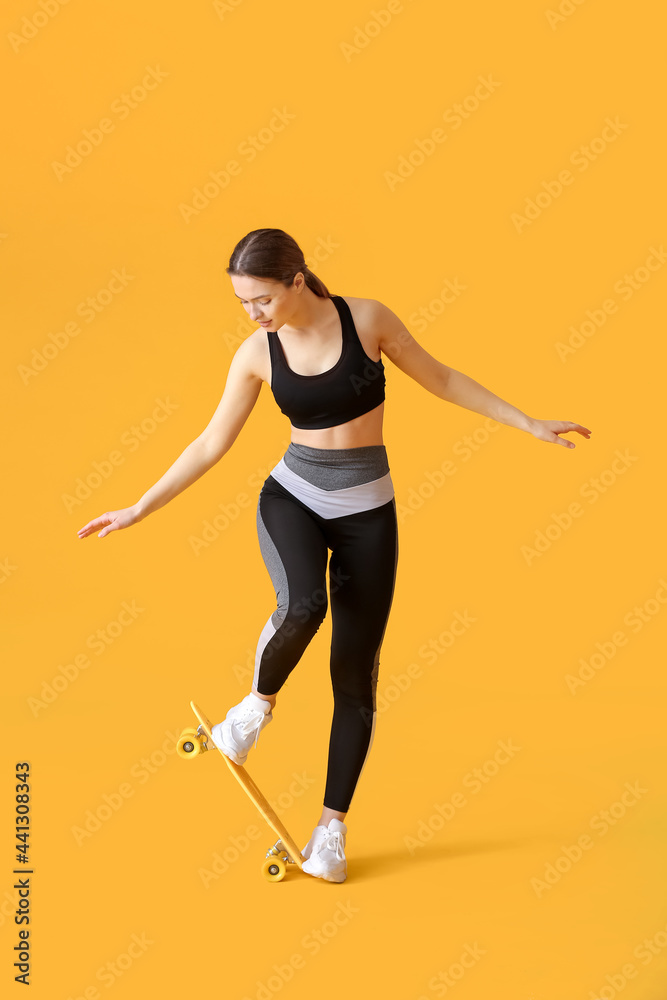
[266,295,385,430]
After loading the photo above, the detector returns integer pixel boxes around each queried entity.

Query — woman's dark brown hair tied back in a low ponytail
[225,229,331,299]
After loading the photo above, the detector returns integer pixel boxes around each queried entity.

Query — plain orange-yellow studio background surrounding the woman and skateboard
[0,0,667,1000]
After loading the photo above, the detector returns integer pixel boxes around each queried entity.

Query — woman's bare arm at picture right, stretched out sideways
[369,299,591,448]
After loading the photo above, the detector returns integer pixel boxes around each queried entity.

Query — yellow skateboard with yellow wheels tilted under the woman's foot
[176,701,304,882]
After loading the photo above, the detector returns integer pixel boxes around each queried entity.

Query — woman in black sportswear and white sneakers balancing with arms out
[79,229,591,882]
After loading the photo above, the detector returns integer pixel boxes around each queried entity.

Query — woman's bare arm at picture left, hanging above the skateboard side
[78,331,263,538]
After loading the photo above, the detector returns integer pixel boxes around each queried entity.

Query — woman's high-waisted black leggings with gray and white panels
[254,444,398,812]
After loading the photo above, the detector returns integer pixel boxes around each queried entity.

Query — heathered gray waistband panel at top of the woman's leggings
[283,441,389,490]
